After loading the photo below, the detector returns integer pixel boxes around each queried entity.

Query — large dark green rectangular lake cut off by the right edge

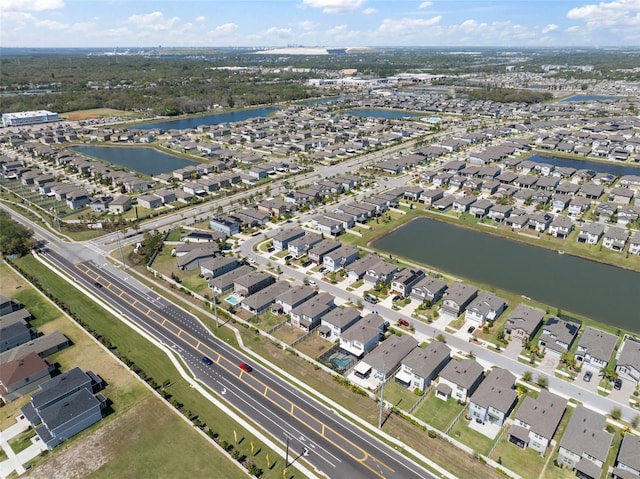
[372,218,640,332]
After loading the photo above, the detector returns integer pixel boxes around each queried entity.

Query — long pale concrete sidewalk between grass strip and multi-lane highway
[29,254,320,479]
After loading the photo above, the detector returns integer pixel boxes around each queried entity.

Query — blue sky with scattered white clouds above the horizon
[0,0,640,48]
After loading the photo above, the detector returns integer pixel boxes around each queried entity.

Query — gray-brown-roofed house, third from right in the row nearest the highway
[509,389,567,456]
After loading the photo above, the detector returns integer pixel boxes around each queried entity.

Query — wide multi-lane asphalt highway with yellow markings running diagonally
[8,207,432,479]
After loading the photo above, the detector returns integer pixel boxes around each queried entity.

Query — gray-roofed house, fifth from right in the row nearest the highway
[436,358,484,402]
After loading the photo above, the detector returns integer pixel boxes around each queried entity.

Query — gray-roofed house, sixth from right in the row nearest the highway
[396,341,451,391]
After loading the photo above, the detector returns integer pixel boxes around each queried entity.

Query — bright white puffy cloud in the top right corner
[567,0,640,29]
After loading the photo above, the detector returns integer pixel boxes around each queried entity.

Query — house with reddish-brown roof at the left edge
[0,352,55,403]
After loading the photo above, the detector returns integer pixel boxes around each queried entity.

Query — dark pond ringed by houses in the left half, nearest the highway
[69,145,198,176]
